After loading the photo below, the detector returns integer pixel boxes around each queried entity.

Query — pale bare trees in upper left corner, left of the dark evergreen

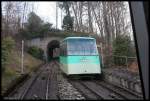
[2,1,34,36]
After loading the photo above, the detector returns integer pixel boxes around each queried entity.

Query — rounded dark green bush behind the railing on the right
[113,35,136,65]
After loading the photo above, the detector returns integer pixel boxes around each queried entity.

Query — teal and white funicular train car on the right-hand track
[60,37,101,75]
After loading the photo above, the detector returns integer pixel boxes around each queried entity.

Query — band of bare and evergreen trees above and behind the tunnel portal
[1,1,136,71]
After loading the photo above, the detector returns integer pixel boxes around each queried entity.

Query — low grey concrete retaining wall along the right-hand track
[102,70,143,95]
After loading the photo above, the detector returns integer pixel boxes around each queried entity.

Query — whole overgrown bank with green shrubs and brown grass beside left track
[1,36,43,94]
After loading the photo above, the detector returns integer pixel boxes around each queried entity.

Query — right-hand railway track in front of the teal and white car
[69,77,142,100]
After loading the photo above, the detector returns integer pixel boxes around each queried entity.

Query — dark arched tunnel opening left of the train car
[47,40,59,61]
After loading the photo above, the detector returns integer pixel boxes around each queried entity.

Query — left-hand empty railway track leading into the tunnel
[6,62,59,99]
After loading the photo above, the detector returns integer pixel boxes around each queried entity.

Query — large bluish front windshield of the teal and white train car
[68,39,98,55]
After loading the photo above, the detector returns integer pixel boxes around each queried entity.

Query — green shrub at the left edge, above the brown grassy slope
[1,36,15,71]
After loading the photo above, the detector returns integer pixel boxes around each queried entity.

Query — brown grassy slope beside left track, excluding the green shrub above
[2,48,43,94]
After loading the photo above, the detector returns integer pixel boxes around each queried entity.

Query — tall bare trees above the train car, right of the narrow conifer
[59,1,131,46]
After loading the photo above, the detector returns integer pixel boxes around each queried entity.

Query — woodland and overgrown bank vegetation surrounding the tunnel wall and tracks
[1,1,138,96]
